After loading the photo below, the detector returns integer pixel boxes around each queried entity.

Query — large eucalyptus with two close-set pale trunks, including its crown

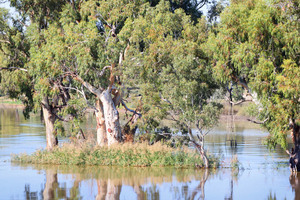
[24,1,152,145]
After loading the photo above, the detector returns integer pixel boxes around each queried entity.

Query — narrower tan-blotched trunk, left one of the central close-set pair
[95,100,107,146]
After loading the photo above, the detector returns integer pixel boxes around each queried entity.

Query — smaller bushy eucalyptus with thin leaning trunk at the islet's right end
[120,1,220,167]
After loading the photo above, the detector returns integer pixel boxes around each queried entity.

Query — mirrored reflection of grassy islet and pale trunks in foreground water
[21,166,213,200]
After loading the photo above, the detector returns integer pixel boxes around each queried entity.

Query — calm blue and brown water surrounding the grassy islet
[0,109,300,200]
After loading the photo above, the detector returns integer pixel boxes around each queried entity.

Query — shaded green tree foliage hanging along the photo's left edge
[0,8,32,114]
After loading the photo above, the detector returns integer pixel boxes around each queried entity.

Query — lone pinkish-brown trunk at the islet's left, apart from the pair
[42,97,58,150]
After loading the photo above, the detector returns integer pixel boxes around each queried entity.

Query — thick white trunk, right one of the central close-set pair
[100,90,123,146]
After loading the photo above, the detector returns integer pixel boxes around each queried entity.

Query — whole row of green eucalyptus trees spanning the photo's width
[0,0,300,167]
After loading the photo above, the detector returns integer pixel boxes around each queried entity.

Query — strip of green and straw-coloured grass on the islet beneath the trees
[12,143,219,167]
